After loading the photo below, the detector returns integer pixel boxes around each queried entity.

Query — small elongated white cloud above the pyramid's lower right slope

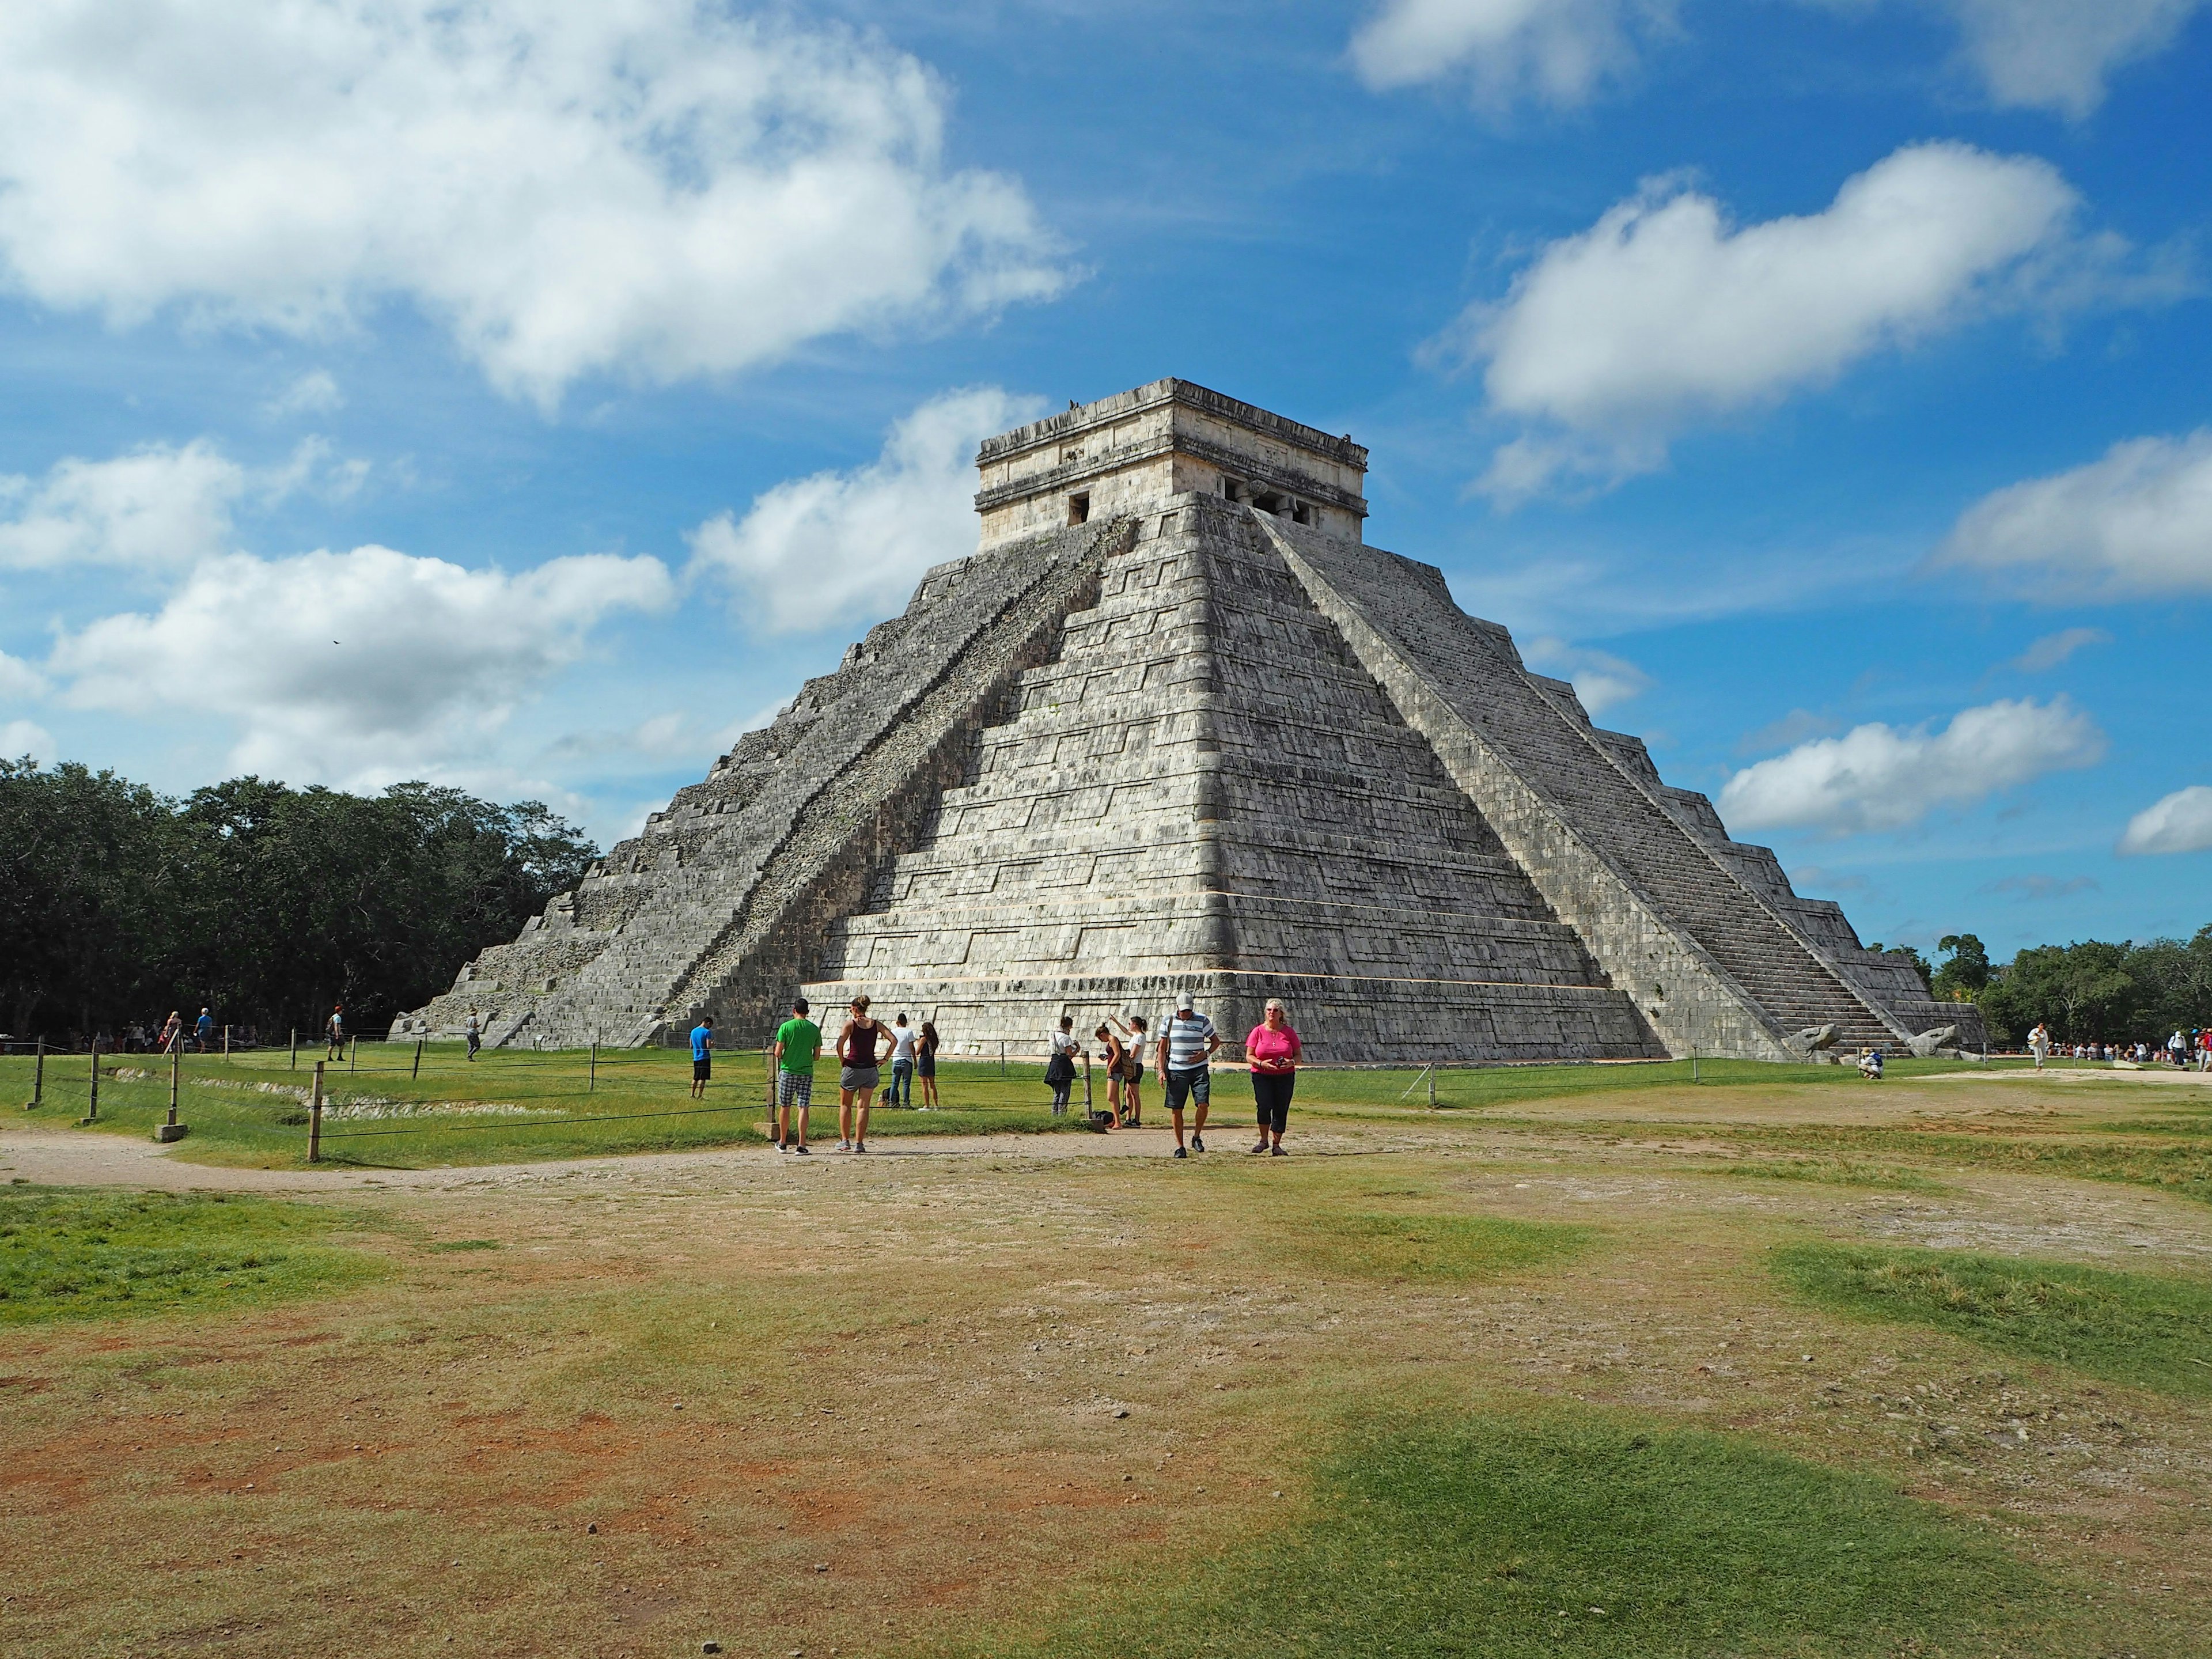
[1719,697,2104,836]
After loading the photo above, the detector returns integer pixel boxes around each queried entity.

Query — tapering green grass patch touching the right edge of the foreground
[1774,1243,2212,1398]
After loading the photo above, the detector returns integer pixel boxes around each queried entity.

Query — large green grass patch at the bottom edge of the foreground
[971,1409,2064,1659]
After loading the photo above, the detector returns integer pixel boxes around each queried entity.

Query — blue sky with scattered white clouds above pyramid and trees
[0,0,2212,958]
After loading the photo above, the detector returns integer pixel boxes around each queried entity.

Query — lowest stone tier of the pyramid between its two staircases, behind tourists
[796,971,1668,1066]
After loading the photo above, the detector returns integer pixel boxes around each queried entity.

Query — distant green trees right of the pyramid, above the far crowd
[1872,927,2212,1046]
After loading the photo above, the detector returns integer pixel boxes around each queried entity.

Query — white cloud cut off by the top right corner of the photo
[1942,0,2203,119]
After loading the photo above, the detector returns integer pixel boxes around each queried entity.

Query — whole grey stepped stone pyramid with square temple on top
[394,380,1978,1064]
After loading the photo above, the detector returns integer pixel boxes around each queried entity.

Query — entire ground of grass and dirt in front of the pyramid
[0,1048,2212,1659]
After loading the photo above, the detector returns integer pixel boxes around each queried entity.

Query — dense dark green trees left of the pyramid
[0,759,600,1044]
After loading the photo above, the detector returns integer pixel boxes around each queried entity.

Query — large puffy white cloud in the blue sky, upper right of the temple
[1445,144,2108,500]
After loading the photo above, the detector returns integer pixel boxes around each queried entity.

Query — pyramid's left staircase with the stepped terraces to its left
[394,522,1130,1046]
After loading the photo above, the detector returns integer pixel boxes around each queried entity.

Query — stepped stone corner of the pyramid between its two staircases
[808,493,1664,1062]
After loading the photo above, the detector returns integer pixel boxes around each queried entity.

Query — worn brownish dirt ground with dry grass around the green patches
[0,1073,2212,1659]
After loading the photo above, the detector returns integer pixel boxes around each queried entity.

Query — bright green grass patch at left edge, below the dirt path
[0,1188,378,1325]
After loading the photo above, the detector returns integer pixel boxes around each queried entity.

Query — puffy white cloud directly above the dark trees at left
[48,546,675,783]
